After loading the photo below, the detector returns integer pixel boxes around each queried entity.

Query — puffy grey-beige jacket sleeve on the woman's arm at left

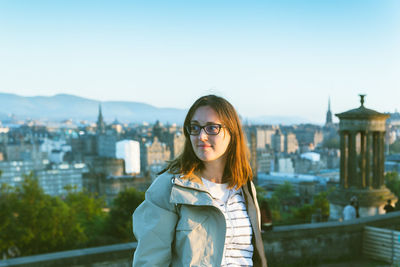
[133,175,178,267]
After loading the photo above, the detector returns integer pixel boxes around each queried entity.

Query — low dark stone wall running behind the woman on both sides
[0,212,400,267]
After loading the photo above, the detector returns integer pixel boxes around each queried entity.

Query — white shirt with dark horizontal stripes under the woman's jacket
[203,178,253,267]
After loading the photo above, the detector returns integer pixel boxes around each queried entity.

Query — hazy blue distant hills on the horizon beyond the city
[0,93,310,125]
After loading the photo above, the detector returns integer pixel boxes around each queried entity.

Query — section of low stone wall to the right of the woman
[263,212,400,267]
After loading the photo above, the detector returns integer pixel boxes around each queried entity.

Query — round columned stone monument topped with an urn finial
[329,95,397,219]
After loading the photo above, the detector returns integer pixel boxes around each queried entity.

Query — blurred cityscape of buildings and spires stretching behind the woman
[0,92,400,266]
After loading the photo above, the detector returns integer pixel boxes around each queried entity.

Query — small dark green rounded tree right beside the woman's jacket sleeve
[106,188,144,242]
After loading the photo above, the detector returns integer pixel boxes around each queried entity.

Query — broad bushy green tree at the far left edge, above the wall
[0,173,86,255]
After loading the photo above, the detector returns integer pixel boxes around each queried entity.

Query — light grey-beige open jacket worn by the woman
[133,172,267,267]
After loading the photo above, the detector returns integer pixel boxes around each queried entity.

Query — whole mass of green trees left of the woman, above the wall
[0,173,144,258]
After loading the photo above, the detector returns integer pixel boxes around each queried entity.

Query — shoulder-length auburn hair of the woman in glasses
[162,95,253,188]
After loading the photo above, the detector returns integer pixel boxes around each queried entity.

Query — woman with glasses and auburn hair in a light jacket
[133,95,267,266]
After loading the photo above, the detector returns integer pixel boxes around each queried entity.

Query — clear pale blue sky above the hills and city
[0,0,400,123]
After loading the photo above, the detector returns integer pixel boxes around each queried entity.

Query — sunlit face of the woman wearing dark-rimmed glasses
[190,106,231,163]
